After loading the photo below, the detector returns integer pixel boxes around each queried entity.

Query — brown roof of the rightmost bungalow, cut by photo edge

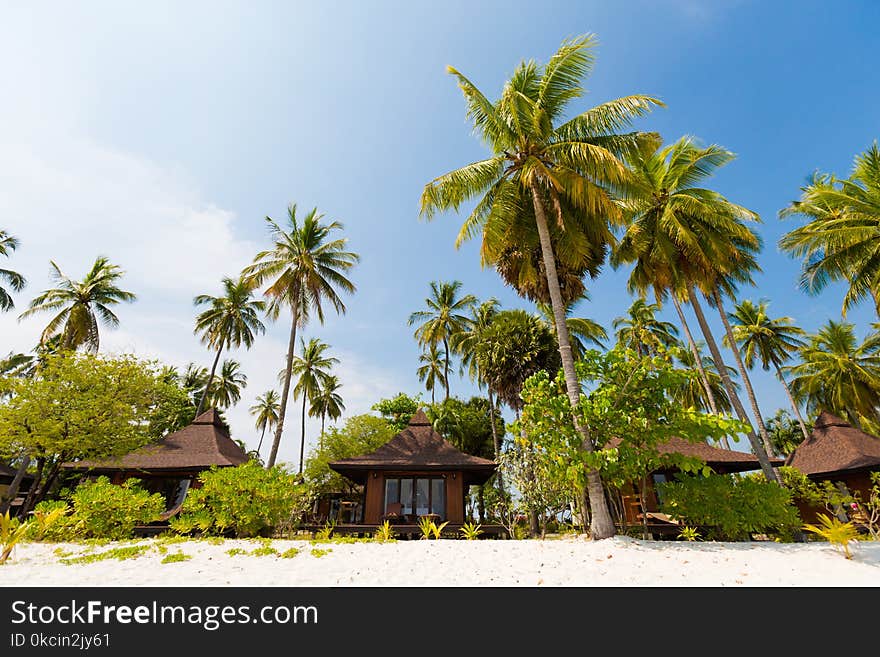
[786,411,880,475]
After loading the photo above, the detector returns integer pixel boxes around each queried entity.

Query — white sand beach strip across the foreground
[0,537,880,587]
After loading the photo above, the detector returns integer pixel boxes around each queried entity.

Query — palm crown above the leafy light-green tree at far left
[19,256,137,353]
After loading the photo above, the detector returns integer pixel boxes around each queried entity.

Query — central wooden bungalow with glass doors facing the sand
[329,409,497,533]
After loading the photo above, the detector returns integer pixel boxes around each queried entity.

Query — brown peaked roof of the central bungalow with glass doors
[329,409,498,481]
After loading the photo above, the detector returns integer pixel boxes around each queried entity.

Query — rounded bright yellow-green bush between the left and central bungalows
[170,461,306,538]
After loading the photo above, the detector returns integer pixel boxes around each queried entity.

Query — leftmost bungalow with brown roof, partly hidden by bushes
[62,408,248,511]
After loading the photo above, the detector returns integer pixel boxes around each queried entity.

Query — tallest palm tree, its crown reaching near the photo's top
[421,35,659,539]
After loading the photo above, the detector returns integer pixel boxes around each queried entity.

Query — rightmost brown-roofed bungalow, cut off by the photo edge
[785,411,880,523]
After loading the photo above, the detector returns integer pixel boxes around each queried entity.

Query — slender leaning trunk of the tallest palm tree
[531,181,615,539]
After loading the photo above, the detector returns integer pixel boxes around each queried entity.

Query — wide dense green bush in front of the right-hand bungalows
[657,475,800,541]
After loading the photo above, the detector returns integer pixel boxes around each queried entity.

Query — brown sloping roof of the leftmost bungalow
[63,408,248,471]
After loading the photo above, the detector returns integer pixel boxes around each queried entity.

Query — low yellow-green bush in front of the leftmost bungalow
[71,477,165,540]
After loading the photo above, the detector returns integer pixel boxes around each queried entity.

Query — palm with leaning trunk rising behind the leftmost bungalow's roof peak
[193,277,266,416]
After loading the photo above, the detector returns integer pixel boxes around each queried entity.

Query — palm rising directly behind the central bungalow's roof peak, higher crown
[408,281,477,399]
